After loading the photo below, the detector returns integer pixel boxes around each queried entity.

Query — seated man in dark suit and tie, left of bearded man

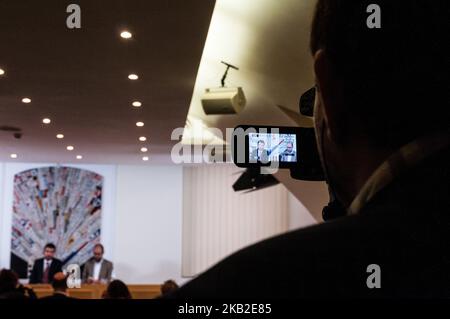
[30,243,62,284]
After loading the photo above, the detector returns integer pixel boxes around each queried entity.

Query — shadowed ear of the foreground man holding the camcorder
[314,49,349,144]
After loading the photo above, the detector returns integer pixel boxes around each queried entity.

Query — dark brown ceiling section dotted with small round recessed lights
[0,0,214,164]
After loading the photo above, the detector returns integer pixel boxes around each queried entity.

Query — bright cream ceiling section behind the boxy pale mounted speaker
[189,0,316,137]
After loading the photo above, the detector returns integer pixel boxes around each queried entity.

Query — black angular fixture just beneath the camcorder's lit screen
[233,167,280,192]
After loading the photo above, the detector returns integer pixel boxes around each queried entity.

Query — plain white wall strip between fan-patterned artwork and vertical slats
[114,166,182,283]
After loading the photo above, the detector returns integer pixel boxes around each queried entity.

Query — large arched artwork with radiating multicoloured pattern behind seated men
[11,166,103,277]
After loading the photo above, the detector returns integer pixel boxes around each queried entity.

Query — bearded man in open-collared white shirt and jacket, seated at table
[82,244,113,284]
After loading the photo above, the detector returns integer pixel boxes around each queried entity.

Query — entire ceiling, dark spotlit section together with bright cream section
[0,0,315,164]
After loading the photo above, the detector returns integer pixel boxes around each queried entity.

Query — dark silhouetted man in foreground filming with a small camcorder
[172,0,450,299]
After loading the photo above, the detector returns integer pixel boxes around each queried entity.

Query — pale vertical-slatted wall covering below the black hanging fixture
[183,164,288,276]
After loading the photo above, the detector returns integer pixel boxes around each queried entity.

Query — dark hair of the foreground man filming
[310,0,450,147]
